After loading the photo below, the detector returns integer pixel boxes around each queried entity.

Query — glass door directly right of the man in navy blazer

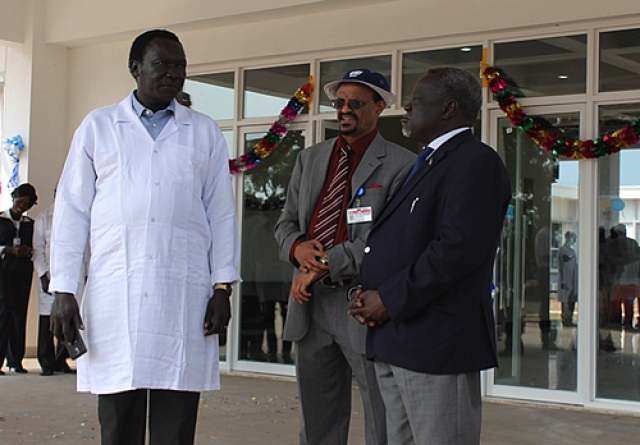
[486,106,588,403]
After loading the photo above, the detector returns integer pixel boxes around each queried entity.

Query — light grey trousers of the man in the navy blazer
[375,360,482,445]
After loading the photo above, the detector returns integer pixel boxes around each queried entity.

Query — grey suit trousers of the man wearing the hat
[294,284,387,445]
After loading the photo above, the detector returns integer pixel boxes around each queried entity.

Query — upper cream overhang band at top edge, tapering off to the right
[43,0,396,46]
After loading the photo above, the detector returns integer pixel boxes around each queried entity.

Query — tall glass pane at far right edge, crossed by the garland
[594,103,640,401]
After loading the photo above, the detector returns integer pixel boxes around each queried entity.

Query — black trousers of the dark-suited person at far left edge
[0,270,33,368]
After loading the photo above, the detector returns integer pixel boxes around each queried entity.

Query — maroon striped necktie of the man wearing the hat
[314,146,351,249]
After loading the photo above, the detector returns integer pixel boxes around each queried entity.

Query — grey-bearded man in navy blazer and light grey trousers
[349,68,511,445]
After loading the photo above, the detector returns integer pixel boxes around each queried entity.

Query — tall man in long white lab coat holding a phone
[50,30,240,445]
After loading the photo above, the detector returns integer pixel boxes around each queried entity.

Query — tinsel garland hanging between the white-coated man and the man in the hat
[229,77,314,174]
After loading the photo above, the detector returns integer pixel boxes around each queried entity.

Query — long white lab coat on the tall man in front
[50,96,240,394]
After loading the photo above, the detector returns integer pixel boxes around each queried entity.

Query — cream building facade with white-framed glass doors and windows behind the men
[0,0,640,413]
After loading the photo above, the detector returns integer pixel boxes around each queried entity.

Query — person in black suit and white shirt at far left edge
[0,183,38,375]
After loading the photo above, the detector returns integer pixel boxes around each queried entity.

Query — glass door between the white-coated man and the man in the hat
[232,125,306,375]
